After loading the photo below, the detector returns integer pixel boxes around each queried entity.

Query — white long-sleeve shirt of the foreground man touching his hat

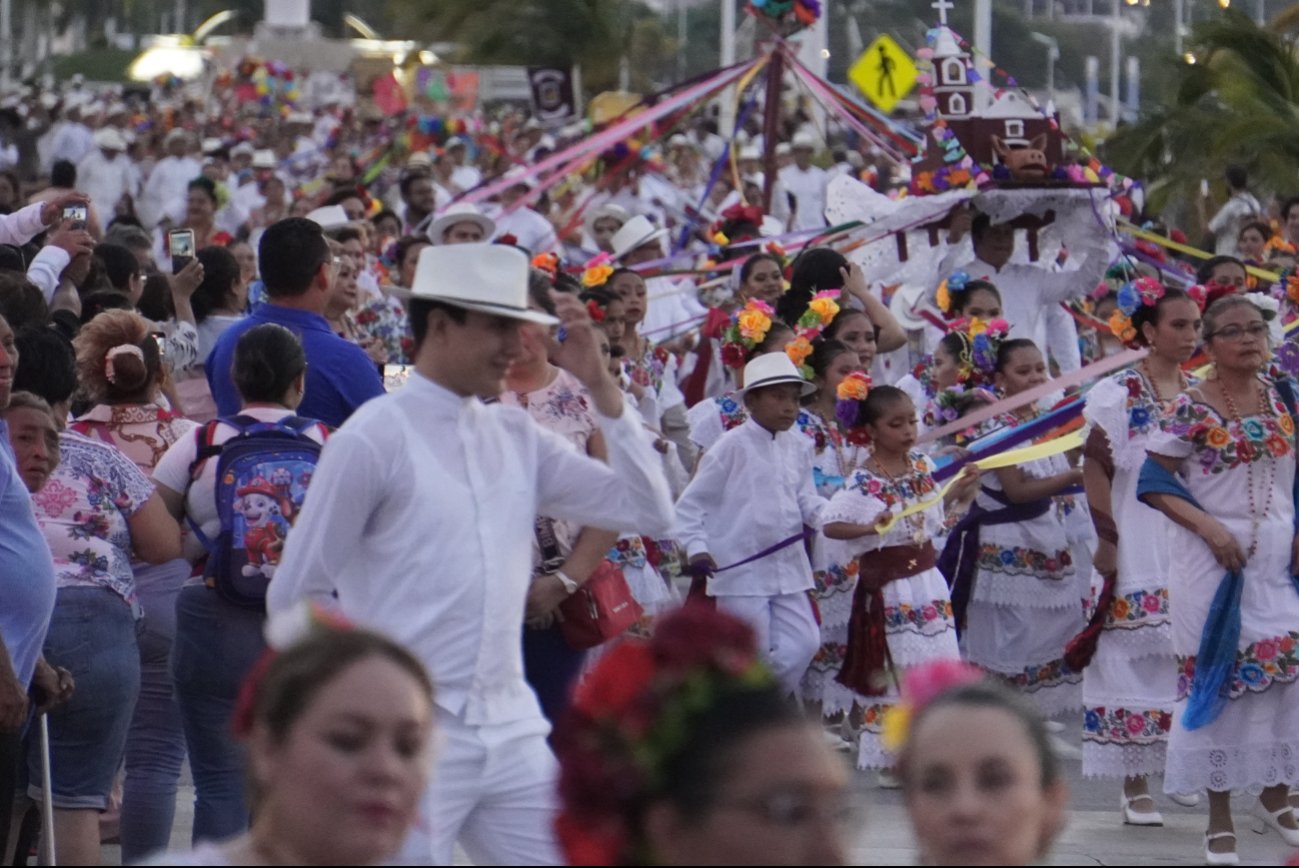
[266,374,673,726]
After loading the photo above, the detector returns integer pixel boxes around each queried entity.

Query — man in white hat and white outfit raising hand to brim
[266,244,672,865]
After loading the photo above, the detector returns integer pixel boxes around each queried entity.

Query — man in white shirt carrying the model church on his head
[938,214,1109,373]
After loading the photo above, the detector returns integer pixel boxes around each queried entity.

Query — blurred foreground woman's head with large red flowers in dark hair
[555,606,852,865]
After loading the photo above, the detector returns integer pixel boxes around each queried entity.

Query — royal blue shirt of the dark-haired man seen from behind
[205,304,383,428]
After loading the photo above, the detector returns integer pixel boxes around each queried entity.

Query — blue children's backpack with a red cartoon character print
[190,416,321,609]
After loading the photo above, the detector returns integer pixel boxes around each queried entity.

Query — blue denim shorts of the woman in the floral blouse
[27,587,140,811]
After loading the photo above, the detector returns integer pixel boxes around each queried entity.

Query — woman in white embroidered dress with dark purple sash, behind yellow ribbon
[939,332,1086,716]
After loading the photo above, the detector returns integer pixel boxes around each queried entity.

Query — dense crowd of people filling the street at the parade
[0,69,1299,864]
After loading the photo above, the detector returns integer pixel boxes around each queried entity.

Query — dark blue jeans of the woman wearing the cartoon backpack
[171,585,266,843]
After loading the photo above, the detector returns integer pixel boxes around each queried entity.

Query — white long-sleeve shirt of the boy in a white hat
[677,418,829,596]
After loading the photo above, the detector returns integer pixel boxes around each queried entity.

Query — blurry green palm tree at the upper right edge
[1105,9,1299,211]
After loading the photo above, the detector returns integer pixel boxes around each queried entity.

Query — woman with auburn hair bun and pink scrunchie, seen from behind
[70,310,194,860]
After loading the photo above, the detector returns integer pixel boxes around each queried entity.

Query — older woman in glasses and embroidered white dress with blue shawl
[1139,295,1299,865]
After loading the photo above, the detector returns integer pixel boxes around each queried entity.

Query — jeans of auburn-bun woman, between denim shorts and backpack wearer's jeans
[121,560,190,864]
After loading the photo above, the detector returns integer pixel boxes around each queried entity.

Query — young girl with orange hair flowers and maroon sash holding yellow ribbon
[824,386,978,784]
